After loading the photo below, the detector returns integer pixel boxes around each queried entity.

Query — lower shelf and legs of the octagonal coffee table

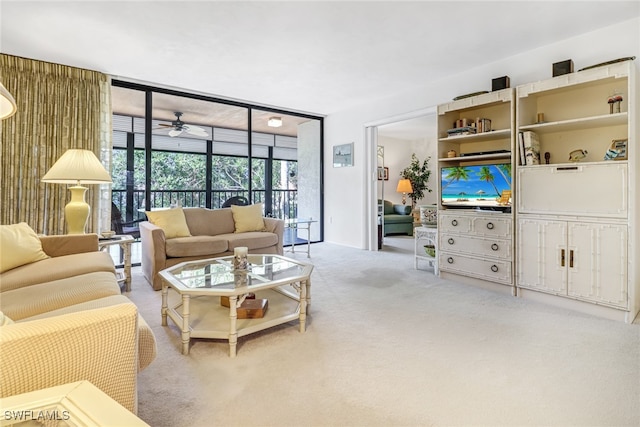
[162,284,308,357]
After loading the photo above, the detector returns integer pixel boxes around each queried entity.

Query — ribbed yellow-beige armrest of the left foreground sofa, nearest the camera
[0,303,138,413]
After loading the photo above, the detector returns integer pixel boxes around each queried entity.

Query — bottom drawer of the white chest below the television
[438,251,511,285]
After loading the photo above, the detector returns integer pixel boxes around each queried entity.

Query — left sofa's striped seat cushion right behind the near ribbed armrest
[0,271,120,321]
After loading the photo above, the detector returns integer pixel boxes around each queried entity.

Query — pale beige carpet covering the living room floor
[129,238,640,427]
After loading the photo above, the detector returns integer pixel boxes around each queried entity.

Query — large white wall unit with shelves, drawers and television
[438,60,640,322]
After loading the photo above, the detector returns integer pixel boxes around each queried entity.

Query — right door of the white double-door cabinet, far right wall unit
[568,222,627,307]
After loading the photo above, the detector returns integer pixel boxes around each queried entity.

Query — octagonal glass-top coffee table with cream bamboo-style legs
[160,254,313,357]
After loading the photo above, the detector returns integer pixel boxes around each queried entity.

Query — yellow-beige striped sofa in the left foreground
[0,234,156,413]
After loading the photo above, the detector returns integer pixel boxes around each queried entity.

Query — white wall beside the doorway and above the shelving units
[324,18,640,248]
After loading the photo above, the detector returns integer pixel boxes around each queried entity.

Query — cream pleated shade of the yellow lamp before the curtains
[42,149,111,185]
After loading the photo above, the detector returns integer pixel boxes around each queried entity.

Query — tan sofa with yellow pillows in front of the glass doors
[140,208,284,290]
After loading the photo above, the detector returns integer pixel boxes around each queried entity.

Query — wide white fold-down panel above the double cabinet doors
[517,161,628,218]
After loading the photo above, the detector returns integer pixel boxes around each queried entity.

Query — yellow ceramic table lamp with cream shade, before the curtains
[42,149,111,234]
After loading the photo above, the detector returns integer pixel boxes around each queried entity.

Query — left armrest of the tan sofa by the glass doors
[140,221,167,290]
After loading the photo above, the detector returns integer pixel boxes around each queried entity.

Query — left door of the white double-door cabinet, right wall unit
[516,219,567,295]
